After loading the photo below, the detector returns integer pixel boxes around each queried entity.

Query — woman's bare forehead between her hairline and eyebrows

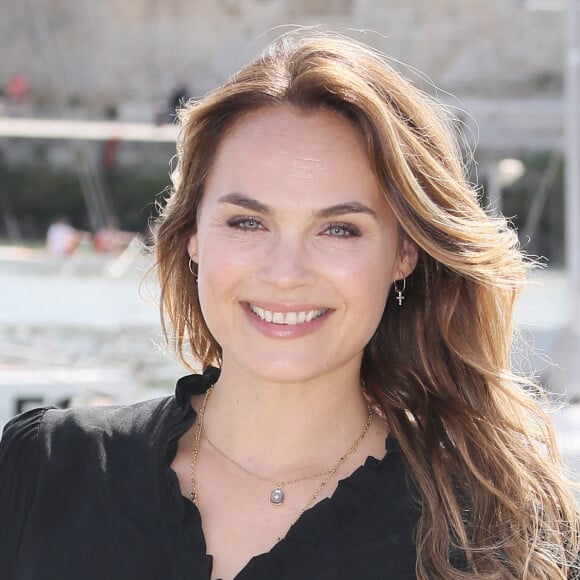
[207,105,380,201]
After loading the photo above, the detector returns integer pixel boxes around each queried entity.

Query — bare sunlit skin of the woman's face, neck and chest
[173,106,416,578]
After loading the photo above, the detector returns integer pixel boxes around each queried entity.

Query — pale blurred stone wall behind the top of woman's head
[0,0,564,117]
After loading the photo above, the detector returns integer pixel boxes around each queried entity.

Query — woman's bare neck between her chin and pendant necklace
[199,367,368,477]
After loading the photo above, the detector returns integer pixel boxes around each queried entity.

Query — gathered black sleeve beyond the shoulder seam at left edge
[0,408,48,578]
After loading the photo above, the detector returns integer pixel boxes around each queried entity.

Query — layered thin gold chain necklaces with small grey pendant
[189,386,373,510]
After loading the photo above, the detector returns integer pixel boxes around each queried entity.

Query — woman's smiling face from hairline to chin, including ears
[188,106,416,382]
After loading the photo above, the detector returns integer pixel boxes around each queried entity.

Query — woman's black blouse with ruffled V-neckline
[0,369,419,580]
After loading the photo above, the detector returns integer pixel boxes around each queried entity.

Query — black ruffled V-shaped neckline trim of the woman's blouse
[165,367,416,580]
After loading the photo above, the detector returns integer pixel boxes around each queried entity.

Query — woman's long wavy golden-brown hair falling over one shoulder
[156,29,580,580]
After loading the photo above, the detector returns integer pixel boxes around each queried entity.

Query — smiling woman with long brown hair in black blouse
[0,31,580,580]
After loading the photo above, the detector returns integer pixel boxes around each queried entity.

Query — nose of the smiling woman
[259,230,313,289]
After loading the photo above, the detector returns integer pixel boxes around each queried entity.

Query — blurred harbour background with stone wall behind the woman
[0,0,580,471]
